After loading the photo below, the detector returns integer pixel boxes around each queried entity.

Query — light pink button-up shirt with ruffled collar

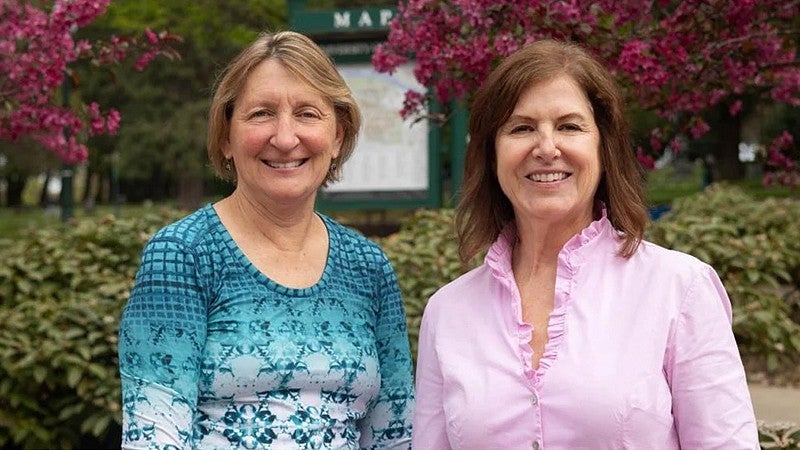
[412,218,759,450]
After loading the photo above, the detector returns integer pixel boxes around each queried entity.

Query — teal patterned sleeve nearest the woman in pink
[359,249,414,449]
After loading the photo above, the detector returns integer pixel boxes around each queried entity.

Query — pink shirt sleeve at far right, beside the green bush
[667,266,759,449]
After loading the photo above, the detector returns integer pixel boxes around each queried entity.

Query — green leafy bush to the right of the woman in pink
[648,185,800,370]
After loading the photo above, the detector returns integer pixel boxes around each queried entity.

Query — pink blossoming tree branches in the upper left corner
[0,0,179,163]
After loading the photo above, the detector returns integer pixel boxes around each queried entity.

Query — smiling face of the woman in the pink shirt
[495,75,601,232]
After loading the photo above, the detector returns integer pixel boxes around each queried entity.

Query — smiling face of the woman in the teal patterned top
[222,59,343,204]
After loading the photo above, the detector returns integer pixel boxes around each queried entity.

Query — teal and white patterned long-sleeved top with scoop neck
[119,205,414,449]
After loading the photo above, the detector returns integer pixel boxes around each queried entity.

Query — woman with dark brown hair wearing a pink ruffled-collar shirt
[413,40,758,450]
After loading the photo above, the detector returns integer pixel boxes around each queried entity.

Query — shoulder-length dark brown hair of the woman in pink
[456,40,649,263]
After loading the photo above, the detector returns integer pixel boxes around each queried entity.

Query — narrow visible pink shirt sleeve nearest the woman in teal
[412,302,451,450]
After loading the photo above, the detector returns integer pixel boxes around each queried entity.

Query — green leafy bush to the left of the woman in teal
[0,212,184,449]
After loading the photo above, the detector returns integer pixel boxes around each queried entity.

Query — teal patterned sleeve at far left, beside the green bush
[119,236,206,449]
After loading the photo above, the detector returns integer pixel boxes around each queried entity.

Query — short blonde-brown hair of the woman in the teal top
[206,31,361,186]
